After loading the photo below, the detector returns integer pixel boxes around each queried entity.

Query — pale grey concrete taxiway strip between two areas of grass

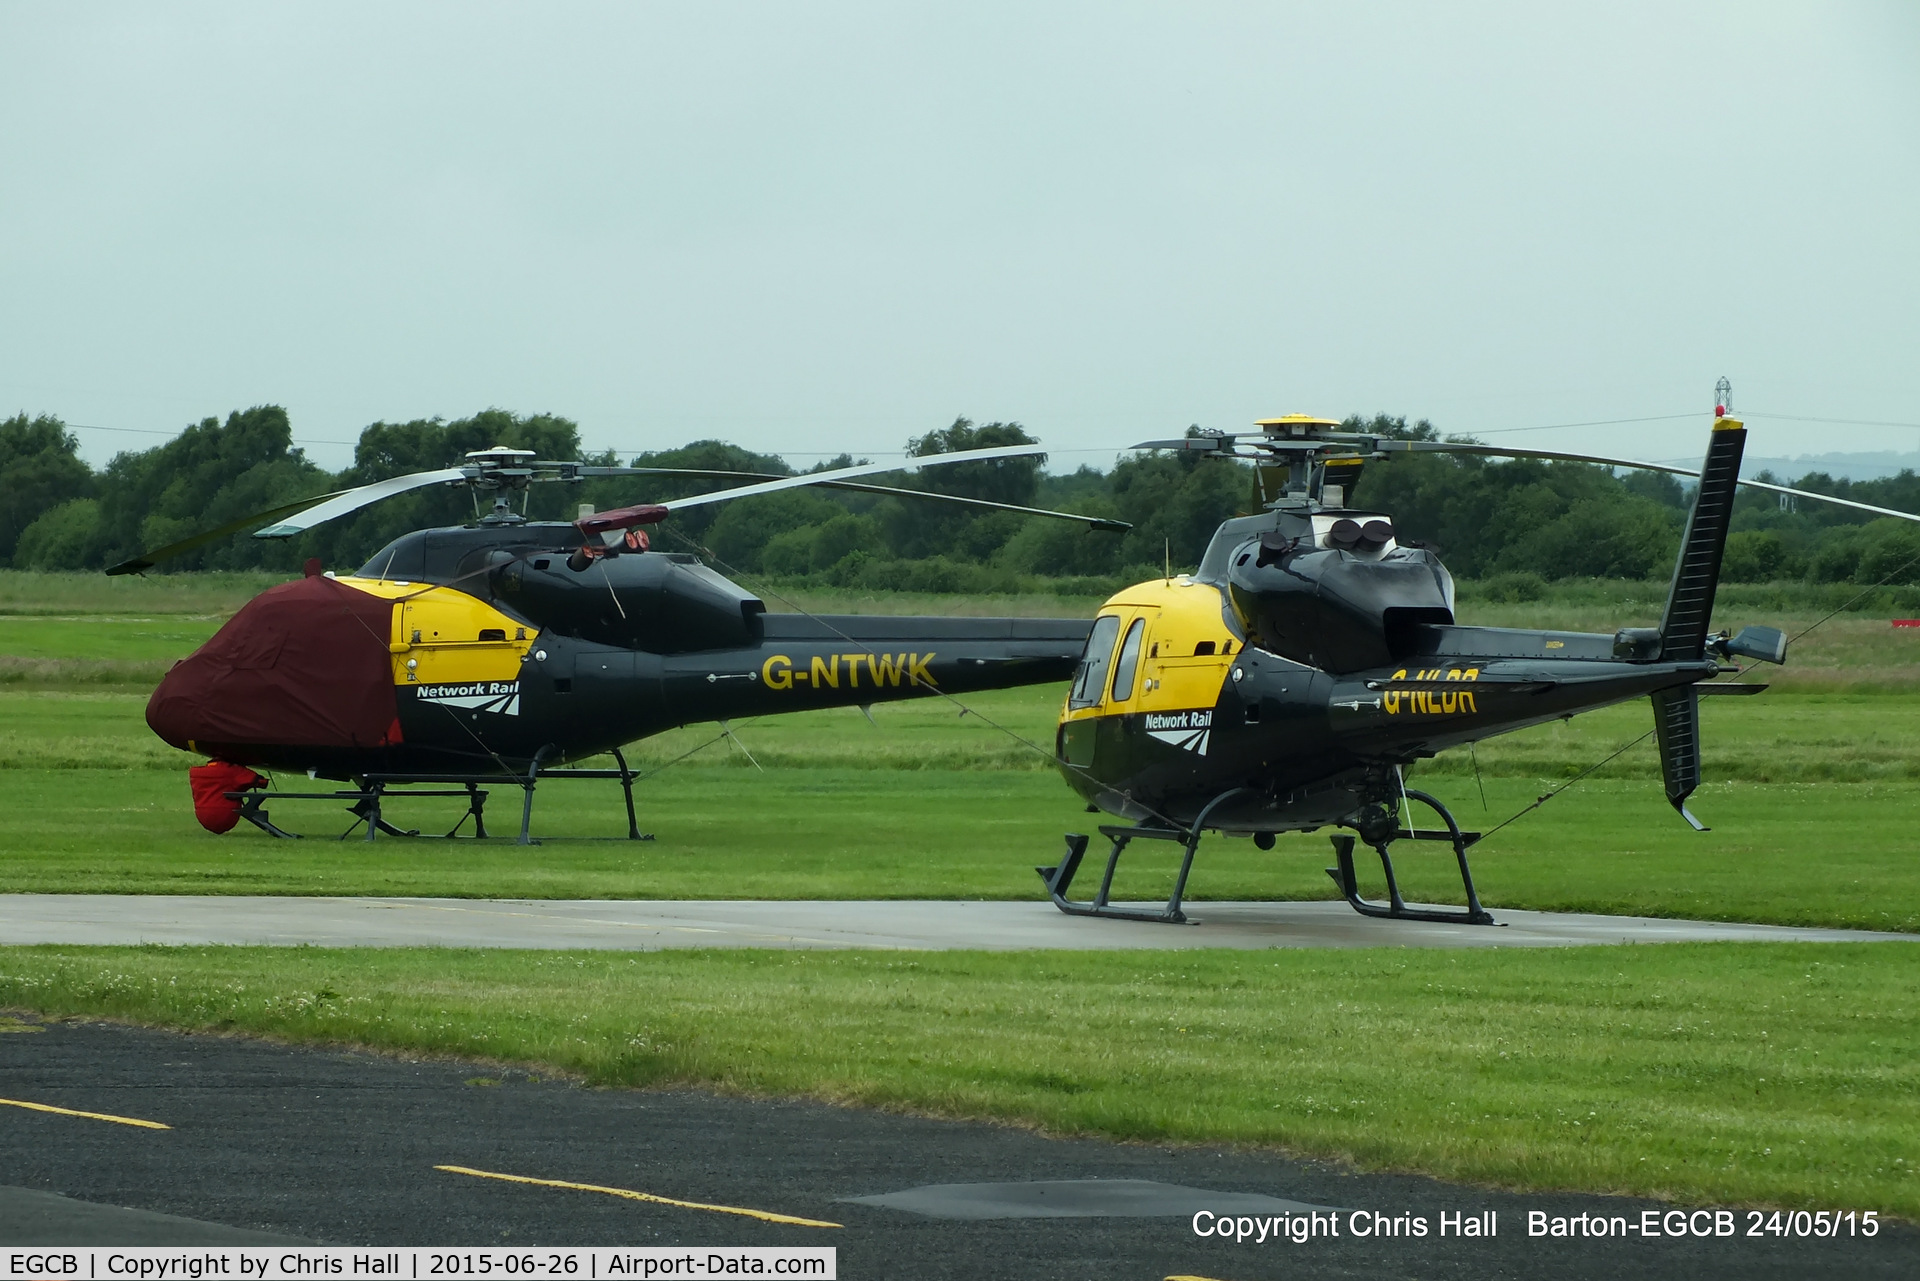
[0,895,1920,951]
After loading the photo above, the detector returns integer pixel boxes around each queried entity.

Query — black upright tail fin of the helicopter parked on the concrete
[1653,419,1747,832]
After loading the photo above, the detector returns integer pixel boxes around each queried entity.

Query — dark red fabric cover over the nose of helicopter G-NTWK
[146,576,399,764]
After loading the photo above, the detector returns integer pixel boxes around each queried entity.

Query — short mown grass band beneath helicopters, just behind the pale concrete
[0,766,1920,931]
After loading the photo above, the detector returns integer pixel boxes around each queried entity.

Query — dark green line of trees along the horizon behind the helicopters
[0,405,1920,592]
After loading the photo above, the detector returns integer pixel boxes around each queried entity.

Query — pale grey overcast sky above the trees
[0,0,1920,469]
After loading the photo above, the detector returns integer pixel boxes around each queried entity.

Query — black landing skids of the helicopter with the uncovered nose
[1033,789,1500,926]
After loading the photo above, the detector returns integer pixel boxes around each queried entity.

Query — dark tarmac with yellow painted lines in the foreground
[0,1024,1920,1281]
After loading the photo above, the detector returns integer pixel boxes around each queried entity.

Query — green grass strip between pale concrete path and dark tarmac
[0,943,1920,1218]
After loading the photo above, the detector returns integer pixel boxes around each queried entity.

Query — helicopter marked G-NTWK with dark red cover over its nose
[123,444,1131,843]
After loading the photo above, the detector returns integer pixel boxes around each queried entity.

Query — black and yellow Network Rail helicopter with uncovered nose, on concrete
[1035,405,1920,926]
